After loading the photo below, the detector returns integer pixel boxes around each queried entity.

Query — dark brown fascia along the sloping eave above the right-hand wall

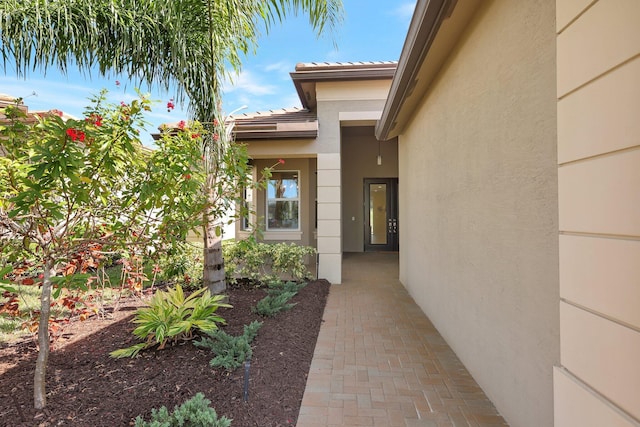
[375,0,457,141]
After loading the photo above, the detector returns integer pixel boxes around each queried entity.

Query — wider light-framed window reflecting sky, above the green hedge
[267,171,300,230]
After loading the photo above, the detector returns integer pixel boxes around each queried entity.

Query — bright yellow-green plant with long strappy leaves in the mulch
[110,285,231,358]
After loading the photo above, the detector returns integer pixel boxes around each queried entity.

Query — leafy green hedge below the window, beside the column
[222,237,316,283]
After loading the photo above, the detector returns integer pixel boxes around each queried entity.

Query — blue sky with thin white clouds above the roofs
[0,0,415,143]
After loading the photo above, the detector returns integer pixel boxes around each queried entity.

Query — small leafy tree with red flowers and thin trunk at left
[0,94,204,409]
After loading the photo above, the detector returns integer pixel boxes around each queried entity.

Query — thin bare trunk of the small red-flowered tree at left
[33,259,53,409]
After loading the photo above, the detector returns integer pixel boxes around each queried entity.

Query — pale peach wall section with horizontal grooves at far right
[554,0,640,427]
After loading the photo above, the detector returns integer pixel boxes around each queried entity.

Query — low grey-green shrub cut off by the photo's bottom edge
[135,393,231,427]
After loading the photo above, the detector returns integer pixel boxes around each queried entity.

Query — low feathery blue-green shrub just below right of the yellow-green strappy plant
[194,320,262,371]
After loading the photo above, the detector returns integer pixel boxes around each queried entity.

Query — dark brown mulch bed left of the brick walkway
[0,280,329,427]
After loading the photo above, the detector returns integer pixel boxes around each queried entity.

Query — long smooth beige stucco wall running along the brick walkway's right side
[398,0,559,427]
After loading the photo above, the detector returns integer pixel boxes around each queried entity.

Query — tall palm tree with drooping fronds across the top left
[0,0,342,300]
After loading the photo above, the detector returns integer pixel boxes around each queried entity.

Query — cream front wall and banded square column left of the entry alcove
[238,83,391,284]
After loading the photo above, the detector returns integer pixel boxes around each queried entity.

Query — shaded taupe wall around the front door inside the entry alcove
[342,126,398,252]
